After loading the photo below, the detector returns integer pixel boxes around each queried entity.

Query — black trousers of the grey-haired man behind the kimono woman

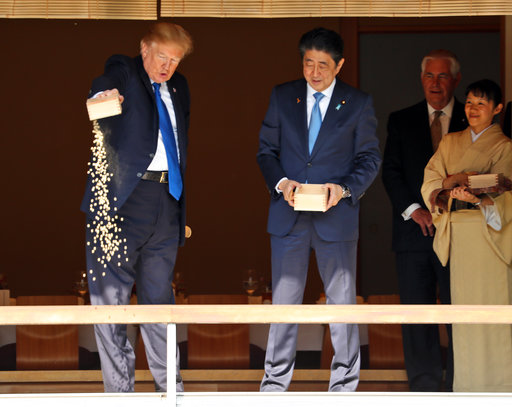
[396,251,453,391]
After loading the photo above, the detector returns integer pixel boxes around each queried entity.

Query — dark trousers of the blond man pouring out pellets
[86,181,183,392]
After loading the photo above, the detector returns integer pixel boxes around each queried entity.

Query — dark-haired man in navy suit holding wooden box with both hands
[257,28,381,391]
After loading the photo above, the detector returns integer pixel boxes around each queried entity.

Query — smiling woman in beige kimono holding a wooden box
[421,80,512,392]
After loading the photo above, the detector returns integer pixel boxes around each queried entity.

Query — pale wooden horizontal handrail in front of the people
[0,304,512,325]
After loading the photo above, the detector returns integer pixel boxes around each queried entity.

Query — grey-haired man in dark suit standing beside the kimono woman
[382,50,467,391]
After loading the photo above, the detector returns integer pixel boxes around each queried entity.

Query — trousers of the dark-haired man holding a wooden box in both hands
[261,213,360,391]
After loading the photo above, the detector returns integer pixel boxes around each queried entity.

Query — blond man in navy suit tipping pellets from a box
[82,23,192,392]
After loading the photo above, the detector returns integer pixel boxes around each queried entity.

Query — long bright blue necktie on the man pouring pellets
[153,82,183,201]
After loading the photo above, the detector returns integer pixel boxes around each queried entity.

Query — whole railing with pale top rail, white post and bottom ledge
[0,305,512,407]
